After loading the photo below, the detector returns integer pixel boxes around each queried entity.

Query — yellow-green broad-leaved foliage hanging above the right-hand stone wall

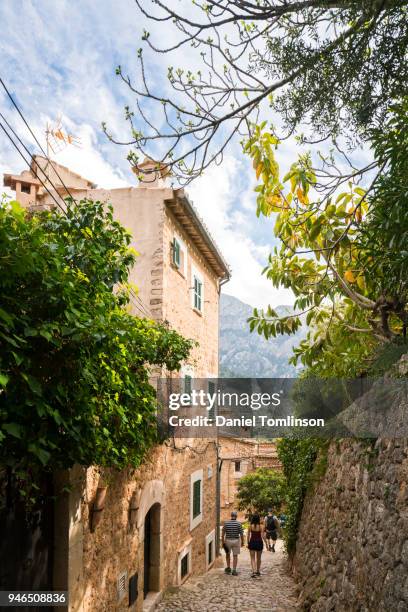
[245,104,408,376]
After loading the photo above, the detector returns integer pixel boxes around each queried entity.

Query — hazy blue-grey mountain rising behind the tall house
[220,294,306,378]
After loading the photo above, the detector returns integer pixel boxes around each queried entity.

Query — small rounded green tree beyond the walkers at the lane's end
[237,468,286,515]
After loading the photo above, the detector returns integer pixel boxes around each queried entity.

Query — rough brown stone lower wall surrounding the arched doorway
[56,441,217,612]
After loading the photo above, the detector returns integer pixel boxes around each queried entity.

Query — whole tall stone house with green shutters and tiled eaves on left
[4,156,229,612]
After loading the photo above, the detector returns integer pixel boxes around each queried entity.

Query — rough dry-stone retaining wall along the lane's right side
[294,438,408,612]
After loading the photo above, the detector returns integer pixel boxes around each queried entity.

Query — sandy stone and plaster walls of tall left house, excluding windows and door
[35,170,226,612]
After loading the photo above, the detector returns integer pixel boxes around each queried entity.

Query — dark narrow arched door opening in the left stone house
[143,503,161,599]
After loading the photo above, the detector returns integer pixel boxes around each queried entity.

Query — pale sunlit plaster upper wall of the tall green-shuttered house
[45,187,219,378]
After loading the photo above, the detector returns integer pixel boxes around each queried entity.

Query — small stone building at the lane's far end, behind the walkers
[218,437,282,521]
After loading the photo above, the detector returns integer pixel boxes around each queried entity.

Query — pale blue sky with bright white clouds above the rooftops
[0,0,298,307]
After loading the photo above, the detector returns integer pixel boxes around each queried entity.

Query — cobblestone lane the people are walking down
[157,540,297,612]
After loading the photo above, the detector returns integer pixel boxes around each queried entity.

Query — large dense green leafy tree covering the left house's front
[0,200,191,500]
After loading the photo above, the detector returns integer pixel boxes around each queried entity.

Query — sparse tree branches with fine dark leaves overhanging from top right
[104,0,408,182]
